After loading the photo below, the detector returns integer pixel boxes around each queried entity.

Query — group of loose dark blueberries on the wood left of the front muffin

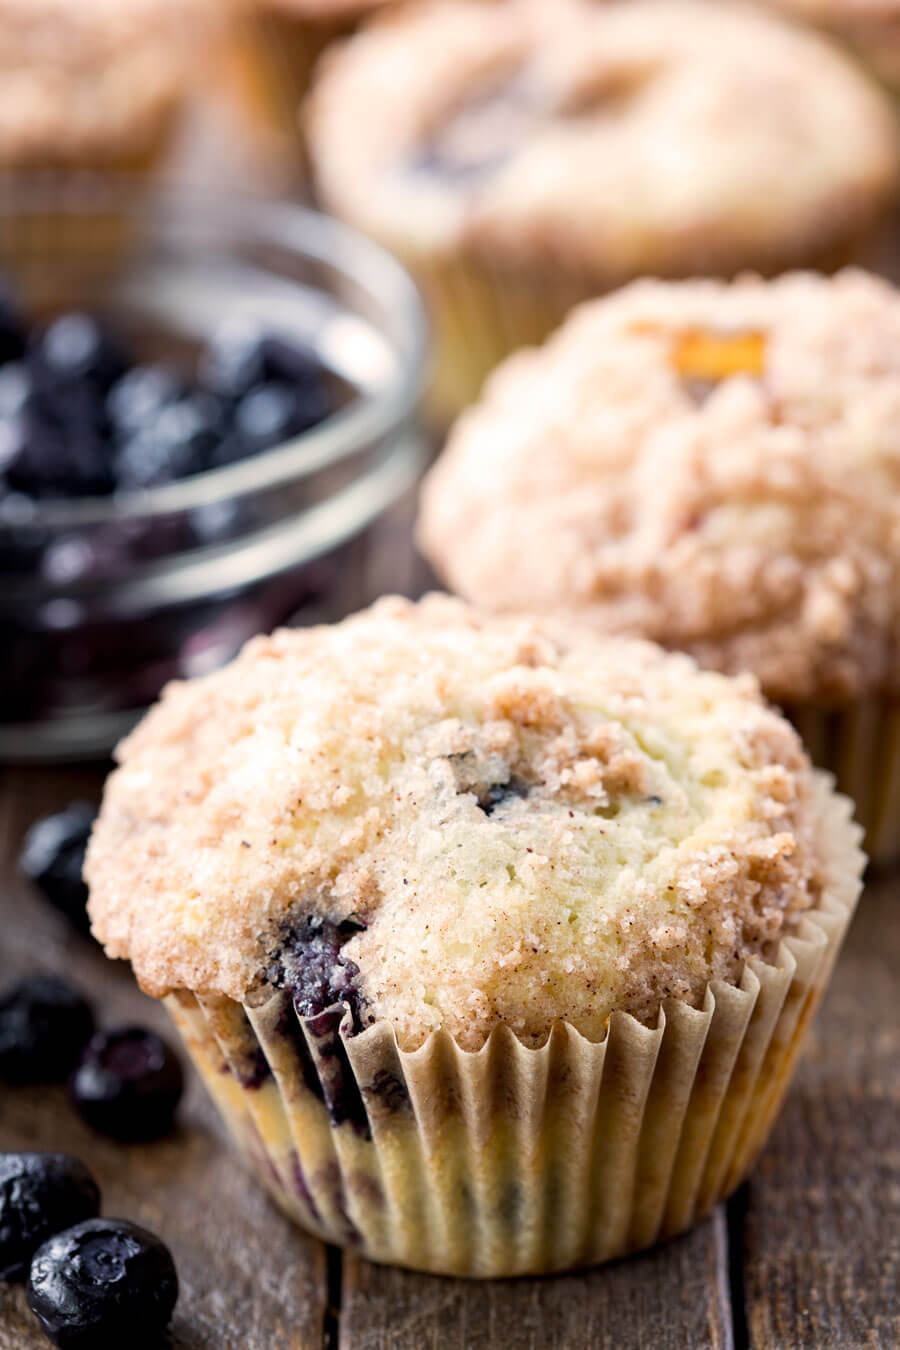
[0,802,184,1350]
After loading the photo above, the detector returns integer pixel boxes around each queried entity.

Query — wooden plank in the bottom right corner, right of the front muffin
[733,880,900,1350]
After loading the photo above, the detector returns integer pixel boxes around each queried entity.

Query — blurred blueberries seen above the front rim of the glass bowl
[0,288,335,571]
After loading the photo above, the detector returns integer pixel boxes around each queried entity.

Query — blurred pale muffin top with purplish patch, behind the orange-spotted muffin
[309,0,897,276]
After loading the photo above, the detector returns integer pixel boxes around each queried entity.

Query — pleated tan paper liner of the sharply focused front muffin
[166,776,864,1276]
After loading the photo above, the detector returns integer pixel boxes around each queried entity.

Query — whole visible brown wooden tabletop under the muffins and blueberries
[0,491,900,1350]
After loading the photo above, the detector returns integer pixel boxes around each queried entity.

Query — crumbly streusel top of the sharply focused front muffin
[85,597,823,1048]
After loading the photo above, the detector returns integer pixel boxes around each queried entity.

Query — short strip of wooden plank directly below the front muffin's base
[339,1211,733,1350]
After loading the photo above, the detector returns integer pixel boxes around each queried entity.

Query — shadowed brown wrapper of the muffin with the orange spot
[781,694,900,867]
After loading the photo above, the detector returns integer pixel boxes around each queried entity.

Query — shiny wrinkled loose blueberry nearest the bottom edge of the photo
[27,1219,178,1350]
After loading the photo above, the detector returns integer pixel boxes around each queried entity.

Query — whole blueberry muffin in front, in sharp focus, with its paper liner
[86,597,862,1276]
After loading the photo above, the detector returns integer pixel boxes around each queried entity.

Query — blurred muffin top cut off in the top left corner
[0,0,212,167]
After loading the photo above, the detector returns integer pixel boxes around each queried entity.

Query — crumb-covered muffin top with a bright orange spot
[418,271,900,702]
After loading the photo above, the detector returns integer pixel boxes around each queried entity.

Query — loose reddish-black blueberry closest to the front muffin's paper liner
[72,1026,185,1141]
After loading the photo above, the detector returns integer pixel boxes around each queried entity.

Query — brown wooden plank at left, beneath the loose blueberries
[0,770,328,1350]
